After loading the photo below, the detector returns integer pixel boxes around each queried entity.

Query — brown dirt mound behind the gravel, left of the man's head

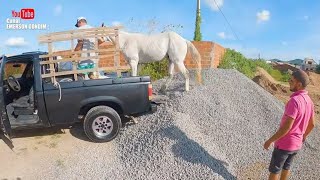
[252,67,290,95]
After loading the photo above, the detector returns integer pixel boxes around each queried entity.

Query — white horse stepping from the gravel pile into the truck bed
[110,31,201,91]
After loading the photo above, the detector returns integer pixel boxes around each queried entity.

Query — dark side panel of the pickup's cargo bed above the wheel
[38,76,151,124]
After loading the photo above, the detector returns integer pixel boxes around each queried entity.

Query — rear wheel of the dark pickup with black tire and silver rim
[83,106,121,143]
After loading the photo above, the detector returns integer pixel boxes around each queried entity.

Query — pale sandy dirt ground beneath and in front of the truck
[0,125,119,180]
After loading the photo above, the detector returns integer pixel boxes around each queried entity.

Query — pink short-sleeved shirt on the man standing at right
[275,90,314,151]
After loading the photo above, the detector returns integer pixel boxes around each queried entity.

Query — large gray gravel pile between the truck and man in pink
[116,69,320,179]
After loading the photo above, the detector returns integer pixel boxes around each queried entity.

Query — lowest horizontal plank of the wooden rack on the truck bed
[41,66,130,78]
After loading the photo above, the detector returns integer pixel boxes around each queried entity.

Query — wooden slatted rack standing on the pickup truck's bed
[38,26,130,82]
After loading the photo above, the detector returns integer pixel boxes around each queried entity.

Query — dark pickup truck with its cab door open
[0,51,156,145]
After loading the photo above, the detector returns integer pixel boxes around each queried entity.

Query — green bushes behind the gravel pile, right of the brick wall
[219,49,290,82]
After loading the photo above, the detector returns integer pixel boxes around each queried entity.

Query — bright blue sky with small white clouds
[0,0,320,62]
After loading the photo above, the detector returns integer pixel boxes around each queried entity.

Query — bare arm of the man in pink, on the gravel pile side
[264,116,294,149]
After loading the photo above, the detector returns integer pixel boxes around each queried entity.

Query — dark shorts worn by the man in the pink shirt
[269,148,298,174]
